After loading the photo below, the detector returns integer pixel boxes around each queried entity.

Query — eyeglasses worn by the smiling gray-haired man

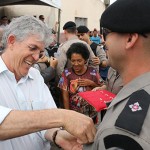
[25,43,45,58]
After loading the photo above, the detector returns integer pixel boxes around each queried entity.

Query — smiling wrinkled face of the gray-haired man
[9,36,44,80]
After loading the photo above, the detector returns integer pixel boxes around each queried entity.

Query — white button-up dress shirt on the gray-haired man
[0,57,56,150]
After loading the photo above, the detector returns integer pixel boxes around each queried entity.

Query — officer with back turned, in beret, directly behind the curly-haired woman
[55,21,100,77]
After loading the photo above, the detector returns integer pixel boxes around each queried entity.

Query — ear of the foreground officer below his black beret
[126,33,139,49]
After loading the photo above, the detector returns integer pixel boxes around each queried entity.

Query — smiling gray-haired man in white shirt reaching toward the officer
[0,16,96,150]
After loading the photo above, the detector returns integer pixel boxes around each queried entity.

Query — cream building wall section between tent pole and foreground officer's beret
[60,0,105,32]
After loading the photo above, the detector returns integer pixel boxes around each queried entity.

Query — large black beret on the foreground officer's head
[100,0,150,33]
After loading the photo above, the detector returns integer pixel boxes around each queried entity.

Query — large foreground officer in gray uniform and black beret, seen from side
[84,0,150,150]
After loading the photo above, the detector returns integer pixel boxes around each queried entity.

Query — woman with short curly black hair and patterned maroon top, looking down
[58,43,105,120]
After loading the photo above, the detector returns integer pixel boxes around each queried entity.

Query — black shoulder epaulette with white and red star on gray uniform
[115,90,150,135]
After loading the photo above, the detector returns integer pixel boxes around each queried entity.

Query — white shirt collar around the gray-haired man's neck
[0,56,33,80]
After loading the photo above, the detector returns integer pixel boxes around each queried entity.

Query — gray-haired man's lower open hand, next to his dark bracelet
[55,130,83,150]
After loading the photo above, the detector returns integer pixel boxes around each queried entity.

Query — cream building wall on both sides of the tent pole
[0,0,105,42]
